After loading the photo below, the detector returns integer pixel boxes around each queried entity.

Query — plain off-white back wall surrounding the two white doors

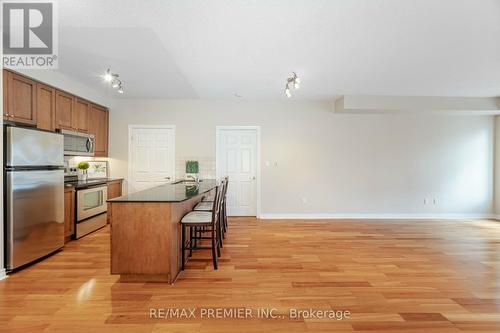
[109,99,494,217]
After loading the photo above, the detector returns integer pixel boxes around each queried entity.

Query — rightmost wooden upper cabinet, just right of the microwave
[89,104,109,157]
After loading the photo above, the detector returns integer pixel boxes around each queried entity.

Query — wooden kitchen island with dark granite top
[108,179,217,283]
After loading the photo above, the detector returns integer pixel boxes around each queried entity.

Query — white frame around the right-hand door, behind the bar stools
[215,126,262,219]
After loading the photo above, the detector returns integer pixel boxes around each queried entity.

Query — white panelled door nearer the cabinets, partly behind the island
[129,126,175,192]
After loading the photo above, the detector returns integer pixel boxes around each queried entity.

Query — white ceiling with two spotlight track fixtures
[50,0,500,100]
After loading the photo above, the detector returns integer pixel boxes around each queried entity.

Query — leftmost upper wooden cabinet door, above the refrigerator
[7,73,36,125]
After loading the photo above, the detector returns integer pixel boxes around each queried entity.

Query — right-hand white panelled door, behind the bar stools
[217,129,257,216]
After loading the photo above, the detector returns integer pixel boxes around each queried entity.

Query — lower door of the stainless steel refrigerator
[6,170,64,270]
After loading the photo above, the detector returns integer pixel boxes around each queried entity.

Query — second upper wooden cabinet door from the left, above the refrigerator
[36,83,56,131]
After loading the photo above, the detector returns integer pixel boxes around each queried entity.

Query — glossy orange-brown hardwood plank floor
[0,218,500,333]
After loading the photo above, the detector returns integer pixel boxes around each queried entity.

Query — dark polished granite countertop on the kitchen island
[108,179,217,202]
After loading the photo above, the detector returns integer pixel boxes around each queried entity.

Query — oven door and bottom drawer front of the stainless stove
[76,185,108,238]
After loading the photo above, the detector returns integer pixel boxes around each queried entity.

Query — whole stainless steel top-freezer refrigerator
[4,126,64,270]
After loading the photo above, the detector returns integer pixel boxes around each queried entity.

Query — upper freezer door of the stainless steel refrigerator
[5,126,64,167]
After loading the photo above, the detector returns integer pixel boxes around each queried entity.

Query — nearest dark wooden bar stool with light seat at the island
[181,184,222,270]
